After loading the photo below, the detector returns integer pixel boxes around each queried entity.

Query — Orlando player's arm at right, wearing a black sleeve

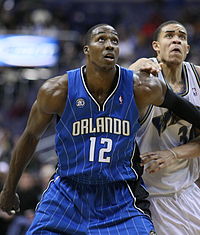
[134,72,200,129]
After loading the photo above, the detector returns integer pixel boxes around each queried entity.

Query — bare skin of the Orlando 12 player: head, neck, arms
[0,25,198,217]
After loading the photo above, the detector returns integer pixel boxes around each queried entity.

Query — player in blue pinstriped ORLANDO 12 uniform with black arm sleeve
[0,24,200,235]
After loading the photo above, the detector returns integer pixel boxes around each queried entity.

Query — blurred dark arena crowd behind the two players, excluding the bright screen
[0,0,200,235]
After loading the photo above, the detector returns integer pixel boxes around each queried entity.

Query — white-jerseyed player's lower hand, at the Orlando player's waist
[140,150,176,174]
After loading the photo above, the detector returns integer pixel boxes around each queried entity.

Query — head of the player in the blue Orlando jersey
[86,25,119,70]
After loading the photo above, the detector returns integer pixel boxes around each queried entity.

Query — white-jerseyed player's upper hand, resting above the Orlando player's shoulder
[129,58,162,76]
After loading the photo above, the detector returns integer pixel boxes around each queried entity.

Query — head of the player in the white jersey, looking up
[153,24,189,64]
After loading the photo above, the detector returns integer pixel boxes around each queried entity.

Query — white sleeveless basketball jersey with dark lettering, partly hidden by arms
[136,58,200,195]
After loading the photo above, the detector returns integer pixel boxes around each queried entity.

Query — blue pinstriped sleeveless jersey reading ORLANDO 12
[56,66,139,184]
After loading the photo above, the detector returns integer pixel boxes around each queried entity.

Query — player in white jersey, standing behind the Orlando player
[130,21,200,235]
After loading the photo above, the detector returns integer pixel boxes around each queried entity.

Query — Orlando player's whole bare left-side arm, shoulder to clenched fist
[0,74,67,214]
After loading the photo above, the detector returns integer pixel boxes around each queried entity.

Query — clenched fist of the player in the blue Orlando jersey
[0,191,20,215]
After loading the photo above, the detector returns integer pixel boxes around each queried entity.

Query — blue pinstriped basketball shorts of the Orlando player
[26,174,155,235]
